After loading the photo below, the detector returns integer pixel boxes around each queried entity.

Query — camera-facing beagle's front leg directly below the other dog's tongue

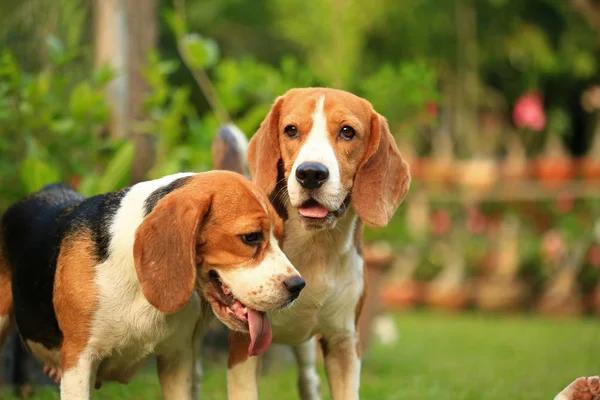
[227,331,260,400]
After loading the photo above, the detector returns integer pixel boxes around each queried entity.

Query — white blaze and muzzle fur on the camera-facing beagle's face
[288,96,343,209]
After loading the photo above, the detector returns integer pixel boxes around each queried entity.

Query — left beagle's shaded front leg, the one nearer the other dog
[157,347,196,400]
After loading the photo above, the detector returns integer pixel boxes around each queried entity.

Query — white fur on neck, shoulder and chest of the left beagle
[86,173,201,381]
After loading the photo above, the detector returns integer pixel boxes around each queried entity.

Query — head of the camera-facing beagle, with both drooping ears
[248,88,410,230]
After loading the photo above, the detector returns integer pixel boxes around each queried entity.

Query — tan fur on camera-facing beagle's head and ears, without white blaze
[248,88,410,226]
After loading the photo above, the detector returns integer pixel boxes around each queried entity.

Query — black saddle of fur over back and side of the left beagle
[0,184,129,349]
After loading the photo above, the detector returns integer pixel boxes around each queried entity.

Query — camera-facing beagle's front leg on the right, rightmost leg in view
[321,331,360,400]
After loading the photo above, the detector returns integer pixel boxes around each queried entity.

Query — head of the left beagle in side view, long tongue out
[134,171,304,353]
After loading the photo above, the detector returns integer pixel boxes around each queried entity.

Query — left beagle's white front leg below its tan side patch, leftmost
[60,342,99,400]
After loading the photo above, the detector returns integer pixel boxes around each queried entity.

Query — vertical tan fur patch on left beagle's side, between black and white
[54,230,98,371]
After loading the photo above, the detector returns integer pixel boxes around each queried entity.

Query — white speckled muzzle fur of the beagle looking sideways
[217,230,300,311]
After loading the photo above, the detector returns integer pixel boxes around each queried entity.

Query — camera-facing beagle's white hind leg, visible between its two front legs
[293,336,321,400]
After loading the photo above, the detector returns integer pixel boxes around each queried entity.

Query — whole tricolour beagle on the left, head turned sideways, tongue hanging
[0,171,305,400]
